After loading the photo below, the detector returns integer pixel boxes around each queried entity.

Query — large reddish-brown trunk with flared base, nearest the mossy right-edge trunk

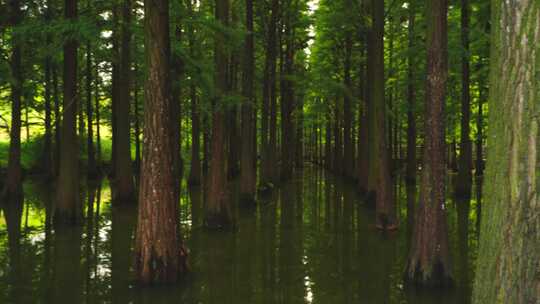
[406,0,452,286]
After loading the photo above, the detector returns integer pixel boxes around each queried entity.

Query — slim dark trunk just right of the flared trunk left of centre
[240,0,257,206]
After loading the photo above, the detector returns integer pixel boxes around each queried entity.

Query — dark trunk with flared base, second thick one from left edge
[54,0,82,225]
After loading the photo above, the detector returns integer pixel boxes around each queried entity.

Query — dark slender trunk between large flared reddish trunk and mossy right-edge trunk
[456,0,472,198]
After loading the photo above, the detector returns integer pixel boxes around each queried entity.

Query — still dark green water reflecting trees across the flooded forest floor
[0,169,478,304]
